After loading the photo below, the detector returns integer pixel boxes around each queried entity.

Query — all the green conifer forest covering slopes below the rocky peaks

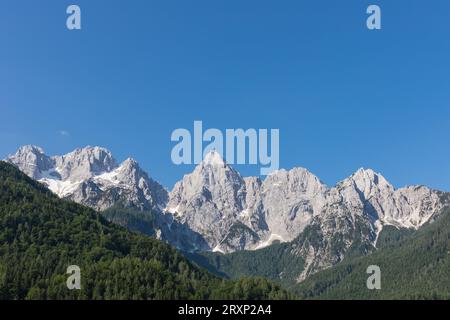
[0,162,450,300]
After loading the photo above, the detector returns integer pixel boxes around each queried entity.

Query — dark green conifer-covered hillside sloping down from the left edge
[0,162,291,299]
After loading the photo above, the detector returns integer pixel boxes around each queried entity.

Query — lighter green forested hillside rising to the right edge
[295,209,450,299]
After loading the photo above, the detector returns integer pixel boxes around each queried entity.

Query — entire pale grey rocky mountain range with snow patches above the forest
[5,146,449,281]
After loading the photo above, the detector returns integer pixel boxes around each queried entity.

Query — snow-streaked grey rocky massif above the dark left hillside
[6,146,168,210]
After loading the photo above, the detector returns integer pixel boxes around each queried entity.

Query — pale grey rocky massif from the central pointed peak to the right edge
[167,153,448,252]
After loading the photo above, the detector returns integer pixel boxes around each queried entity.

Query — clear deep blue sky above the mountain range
[0,0,450,191]
